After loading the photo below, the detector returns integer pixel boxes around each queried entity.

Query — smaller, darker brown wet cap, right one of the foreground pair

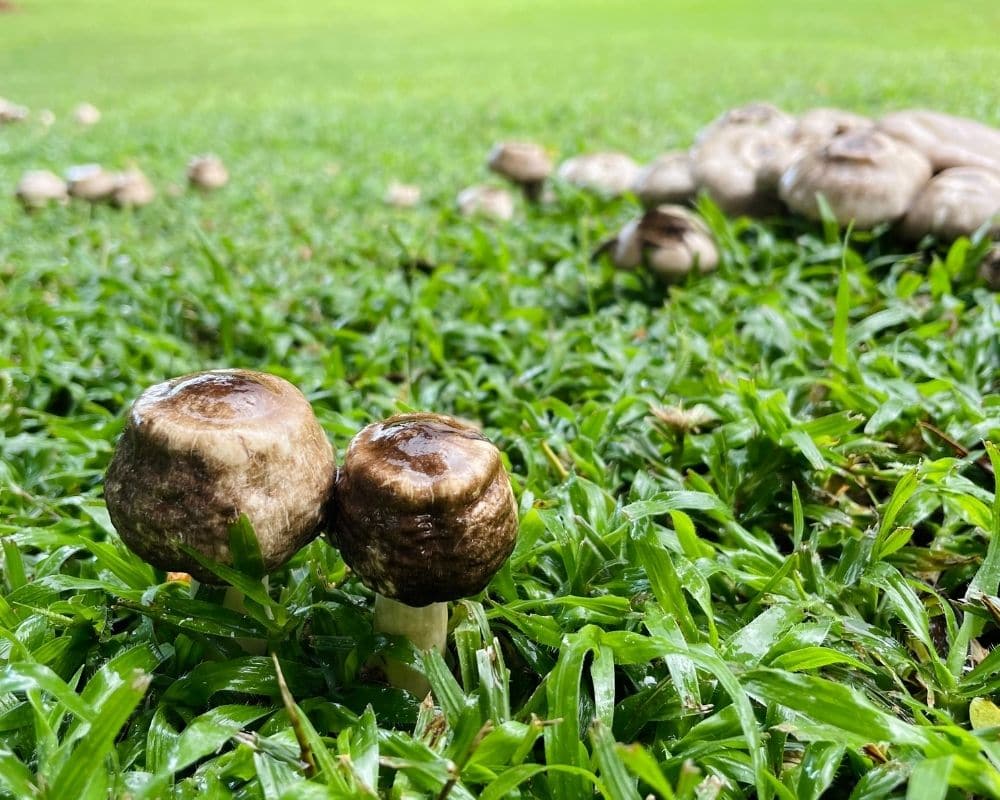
[332,414,518,606]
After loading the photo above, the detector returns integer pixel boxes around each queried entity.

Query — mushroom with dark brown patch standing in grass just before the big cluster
[611,205,719,282]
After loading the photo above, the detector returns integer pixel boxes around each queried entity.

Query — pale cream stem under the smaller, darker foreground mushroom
[375,594,448,697]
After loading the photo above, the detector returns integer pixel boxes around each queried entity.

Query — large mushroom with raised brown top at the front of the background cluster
[779,130,931,230]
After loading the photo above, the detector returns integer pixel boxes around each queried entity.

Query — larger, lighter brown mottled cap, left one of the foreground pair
[104,369,336,583]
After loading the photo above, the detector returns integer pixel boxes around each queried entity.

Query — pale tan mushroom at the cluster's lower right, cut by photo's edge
[900,167,1000,242]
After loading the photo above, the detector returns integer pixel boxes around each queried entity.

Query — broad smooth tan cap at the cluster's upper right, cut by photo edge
[878,109,1000,172]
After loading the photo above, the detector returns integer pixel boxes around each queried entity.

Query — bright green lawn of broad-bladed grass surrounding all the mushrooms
[0,0,1000,800]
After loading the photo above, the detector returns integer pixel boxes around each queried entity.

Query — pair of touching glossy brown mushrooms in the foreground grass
[105,370,518,692]
